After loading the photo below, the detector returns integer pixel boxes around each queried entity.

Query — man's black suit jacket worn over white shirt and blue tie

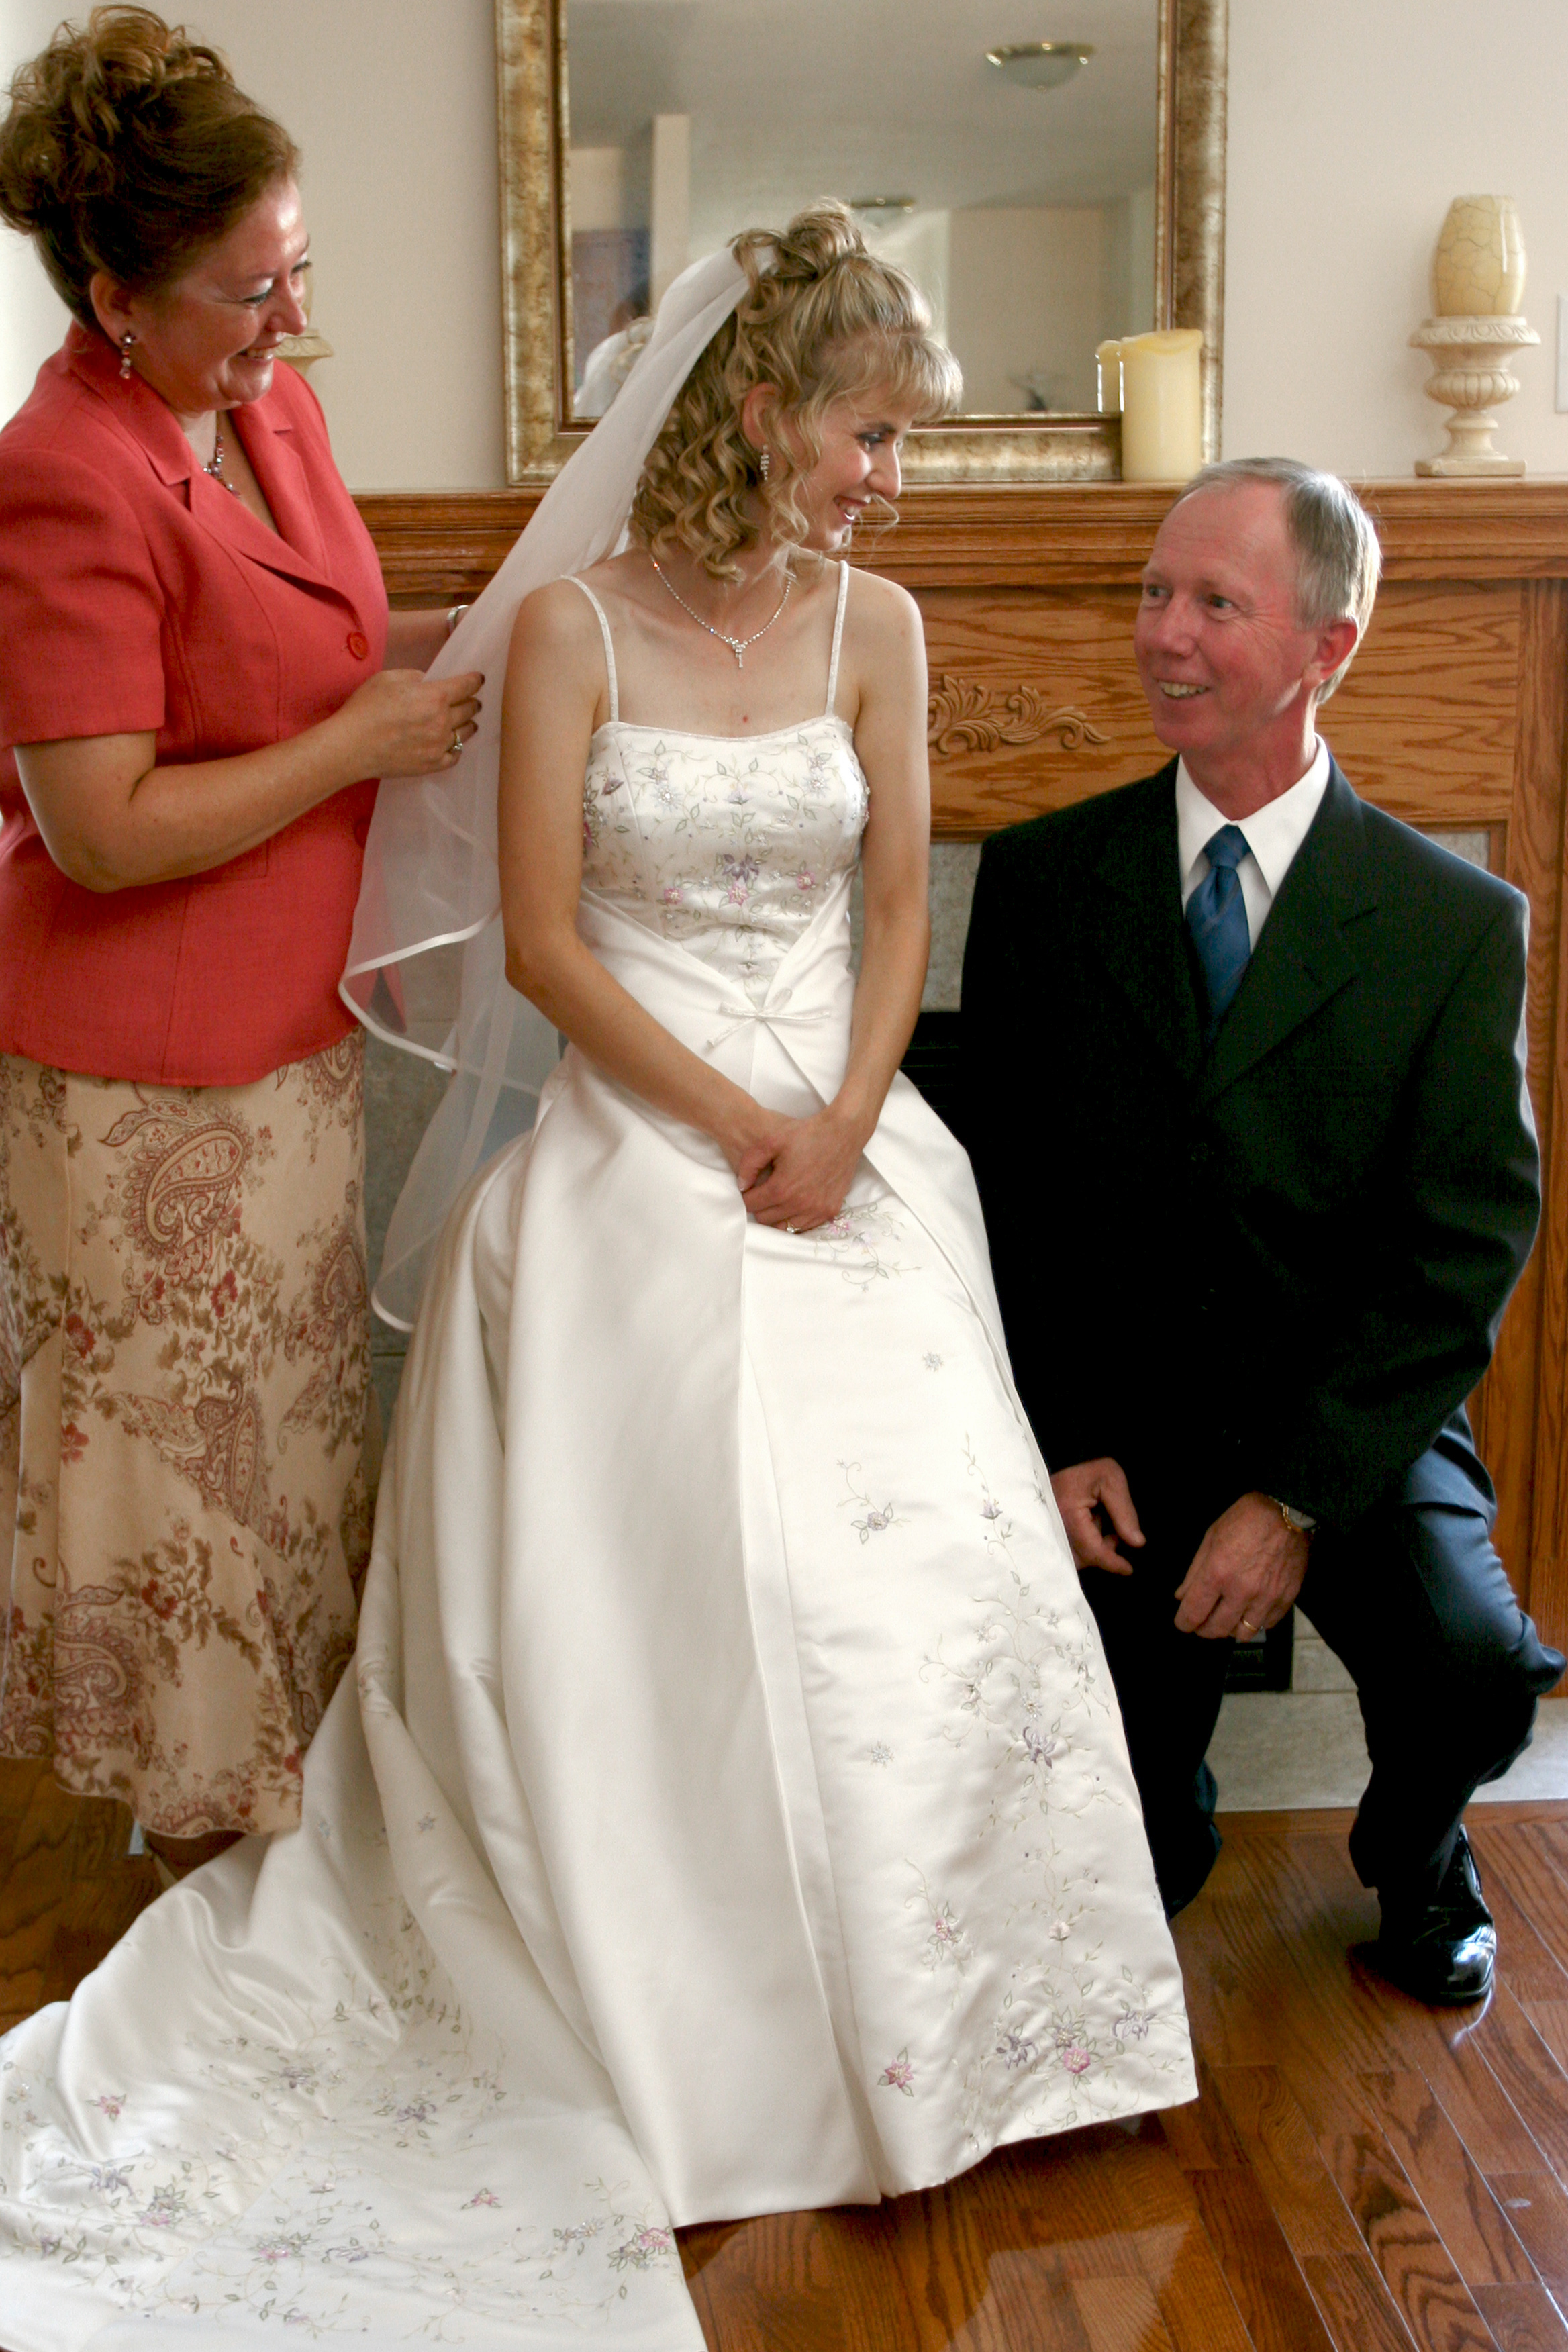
[964,765,1540,1531]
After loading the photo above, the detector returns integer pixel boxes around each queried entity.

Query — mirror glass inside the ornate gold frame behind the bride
[567,0,1159,419]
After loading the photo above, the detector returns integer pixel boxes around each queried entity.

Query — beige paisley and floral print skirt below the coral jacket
[0,1030,379,1837]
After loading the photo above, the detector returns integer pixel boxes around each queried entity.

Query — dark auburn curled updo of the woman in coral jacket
[0,7,299,327]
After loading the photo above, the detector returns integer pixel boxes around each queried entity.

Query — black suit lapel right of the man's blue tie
[1199,762,1375,1103]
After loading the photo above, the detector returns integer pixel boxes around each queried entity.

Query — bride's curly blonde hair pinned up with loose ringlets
[630,200,964,581]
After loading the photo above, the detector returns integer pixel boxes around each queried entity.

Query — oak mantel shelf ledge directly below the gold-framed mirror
[357,475,1568,605]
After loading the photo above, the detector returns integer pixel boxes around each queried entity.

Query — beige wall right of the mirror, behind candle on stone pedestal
[1225,0,1568,475]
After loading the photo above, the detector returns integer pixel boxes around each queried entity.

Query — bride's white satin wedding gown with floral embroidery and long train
[0,573,1194,2352]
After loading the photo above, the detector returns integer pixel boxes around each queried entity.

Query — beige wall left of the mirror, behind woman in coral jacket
[0,0,505,489]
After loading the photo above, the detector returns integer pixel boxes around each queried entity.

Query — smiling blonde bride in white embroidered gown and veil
[0,207,1194,2352]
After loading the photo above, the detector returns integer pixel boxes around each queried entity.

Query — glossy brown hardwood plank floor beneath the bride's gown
[0,1764,1568,2352]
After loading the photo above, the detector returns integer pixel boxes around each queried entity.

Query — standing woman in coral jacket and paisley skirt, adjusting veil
[0,7,479,1870]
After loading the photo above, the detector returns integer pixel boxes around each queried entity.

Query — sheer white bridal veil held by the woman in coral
[338,252,748,1329]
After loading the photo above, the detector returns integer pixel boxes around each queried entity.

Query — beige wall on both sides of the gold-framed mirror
[0,0,1568,489]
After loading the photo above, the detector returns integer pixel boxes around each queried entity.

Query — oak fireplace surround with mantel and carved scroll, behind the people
[360,480,1568,1644]
